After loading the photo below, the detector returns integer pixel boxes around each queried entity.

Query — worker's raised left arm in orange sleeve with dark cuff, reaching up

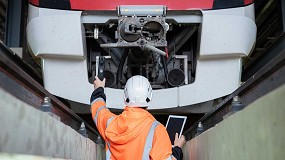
[90,77,115,140]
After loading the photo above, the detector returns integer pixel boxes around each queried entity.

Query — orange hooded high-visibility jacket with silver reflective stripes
[91,88,172,160]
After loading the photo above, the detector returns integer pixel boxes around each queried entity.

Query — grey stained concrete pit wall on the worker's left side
[0,88,103,160]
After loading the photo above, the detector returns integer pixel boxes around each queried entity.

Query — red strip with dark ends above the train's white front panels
[29,0,253,10]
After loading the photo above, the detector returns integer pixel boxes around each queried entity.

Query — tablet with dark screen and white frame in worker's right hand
[166,115,187,145]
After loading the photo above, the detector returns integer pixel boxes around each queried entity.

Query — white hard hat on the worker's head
[124,75,152,107]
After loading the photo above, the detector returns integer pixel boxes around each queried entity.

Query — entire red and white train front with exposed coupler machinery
[27,0,257,113]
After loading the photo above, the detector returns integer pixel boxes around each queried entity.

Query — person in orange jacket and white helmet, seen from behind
[90,76,185,160]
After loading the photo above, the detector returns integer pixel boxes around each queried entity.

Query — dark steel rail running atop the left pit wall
[0,43,99,141]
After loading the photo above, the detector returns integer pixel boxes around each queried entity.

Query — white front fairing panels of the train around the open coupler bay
[27,3,257,112]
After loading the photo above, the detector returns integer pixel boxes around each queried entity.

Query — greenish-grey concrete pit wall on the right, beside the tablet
[184,85,285,160]
